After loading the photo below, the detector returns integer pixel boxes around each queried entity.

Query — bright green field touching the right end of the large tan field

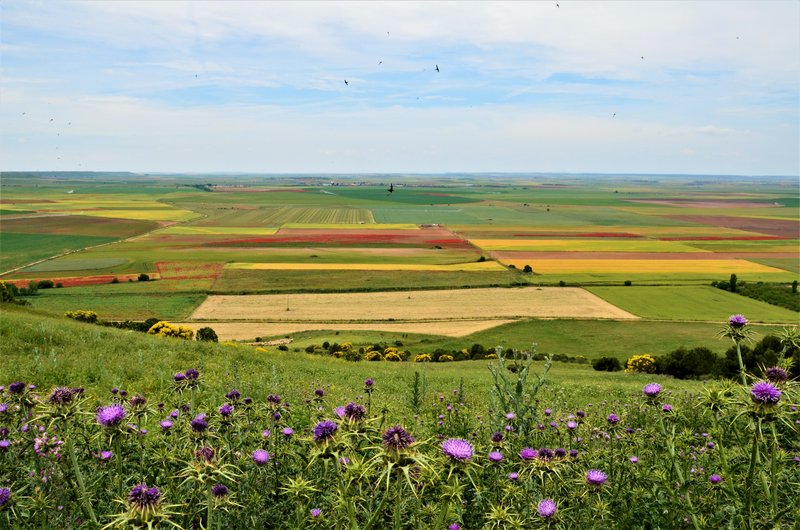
[588,286,797,323]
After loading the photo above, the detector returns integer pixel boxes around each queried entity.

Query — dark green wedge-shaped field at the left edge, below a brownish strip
[0,232,116,271]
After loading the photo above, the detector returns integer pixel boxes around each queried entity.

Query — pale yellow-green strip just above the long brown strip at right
[469,238,705,252]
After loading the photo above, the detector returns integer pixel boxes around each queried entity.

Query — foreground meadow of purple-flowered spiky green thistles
[0,315,800,530]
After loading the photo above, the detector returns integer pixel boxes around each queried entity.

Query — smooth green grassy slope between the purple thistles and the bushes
[0,308,698,413]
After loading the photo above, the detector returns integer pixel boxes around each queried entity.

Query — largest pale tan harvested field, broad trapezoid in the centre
[191,287,636,323]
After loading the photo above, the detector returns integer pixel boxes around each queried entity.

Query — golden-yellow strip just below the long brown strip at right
[503,259,786,275]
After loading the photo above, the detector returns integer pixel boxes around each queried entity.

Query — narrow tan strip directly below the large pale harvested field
[173,320,514,340]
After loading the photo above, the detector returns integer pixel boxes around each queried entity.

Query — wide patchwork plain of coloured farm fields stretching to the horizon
[0,170,800,356]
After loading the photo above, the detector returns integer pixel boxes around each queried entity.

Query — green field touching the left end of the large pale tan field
[26,288,205,320]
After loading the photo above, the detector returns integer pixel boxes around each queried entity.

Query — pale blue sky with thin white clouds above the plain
[0,0,800,176]
